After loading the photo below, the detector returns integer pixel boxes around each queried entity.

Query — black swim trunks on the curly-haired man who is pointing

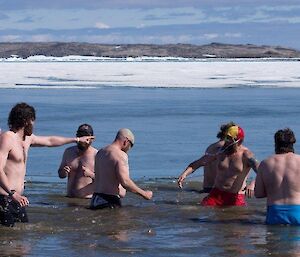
[0,195,28,227]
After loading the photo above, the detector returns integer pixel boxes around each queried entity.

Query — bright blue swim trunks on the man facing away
[266,205,300,225]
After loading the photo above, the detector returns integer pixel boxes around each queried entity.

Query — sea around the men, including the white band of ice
[0,61,300,256]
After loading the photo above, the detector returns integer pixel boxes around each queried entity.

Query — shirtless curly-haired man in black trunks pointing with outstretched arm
[0,103,94,226]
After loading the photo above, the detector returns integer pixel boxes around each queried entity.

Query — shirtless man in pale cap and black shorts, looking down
[90,128,152,209]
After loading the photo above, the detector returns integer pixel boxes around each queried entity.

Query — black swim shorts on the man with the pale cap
[90,193,122,210]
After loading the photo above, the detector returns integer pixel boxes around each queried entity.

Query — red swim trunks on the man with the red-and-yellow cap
[201,188,246,206]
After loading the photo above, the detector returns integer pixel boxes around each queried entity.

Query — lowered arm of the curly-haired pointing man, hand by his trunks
[0,134,29,206]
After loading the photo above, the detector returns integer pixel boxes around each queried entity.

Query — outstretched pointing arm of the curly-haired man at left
[31,135,95,147]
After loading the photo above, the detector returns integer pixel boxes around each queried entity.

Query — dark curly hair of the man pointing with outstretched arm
[7,103,35,131]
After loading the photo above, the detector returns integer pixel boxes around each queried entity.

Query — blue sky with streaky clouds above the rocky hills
[0,0,300,50]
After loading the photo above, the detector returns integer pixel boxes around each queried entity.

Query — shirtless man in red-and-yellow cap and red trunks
[178,125,258,206]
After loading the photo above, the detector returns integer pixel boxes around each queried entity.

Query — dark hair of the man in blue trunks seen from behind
[274,128,296,154]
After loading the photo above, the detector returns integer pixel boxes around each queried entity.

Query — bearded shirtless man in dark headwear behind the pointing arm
[58,124,97,198]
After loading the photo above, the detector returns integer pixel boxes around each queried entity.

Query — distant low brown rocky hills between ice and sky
[0,42,300,58]
